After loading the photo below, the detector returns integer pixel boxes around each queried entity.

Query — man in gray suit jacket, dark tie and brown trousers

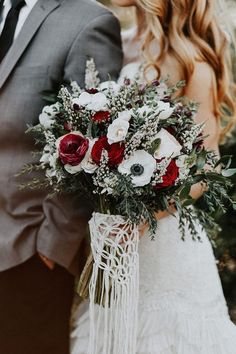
[0,0,122,354]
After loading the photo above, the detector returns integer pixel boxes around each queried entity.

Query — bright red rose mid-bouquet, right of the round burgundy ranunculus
[91,136,125,166]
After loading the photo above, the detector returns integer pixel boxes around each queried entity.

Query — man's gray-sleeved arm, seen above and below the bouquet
[37,11,123,268]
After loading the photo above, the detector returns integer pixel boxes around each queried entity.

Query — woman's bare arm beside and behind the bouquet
[156,62,220,219]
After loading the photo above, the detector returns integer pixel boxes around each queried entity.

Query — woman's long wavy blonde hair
[137,0,236,138]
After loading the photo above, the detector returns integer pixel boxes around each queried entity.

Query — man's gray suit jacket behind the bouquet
[0,0,122,273]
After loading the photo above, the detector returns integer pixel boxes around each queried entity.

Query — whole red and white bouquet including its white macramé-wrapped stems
[21,60,235,353]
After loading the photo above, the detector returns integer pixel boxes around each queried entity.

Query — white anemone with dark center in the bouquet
[118,150,156,187]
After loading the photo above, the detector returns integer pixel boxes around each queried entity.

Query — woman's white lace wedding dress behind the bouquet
[71,27,236,354]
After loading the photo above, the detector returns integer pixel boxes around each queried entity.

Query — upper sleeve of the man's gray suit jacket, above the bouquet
[64,12,123,86]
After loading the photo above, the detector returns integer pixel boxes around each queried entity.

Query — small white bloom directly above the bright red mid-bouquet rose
[107,118,129,144]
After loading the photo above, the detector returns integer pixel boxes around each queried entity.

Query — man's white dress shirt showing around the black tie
[0,0,38,40]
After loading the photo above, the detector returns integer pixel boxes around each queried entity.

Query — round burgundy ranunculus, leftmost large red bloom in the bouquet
[58,133,89,166]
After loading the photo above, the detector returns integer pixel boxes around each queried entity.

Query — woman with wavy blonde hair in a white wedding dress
[72,0,236,354]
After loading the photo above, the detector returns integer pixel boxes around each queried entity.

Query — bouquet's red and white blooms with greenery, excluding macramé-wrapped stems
[23,60,235,238]
